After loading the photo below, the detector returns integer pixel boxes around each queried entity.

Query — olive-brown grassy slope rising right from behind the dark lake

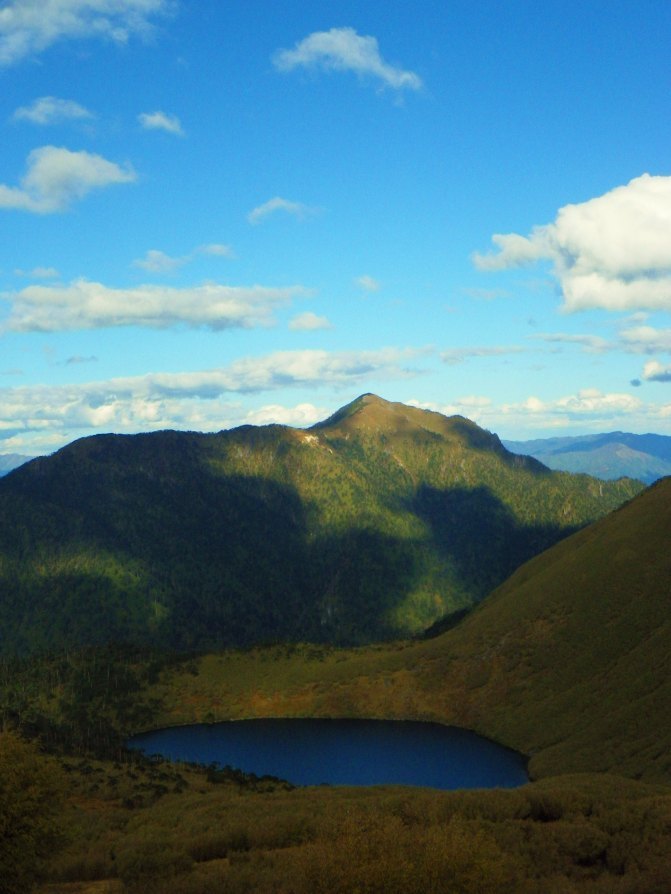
[150,479,671,782]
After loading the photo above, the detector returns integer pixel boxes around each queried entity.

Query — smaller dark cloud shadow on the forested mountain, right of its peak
[409,485,577,599]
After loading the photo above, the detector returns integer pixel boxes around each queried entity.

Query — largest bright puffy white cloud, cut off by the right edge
[474,174,671,311]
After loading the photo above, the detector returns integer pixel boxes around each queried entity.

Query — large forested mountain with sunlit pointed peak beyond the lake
[0,395,641,652]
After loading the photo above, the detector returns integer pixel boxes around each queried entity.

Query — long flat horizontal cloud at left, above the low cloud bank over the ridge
[4,279,308,332]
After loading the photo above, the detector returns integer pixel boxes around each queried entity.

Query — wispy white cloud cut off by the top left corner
[0,0,173,66]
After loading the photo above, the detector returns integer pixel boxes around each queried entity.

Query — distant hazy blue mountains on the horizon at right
[503,431,671,484]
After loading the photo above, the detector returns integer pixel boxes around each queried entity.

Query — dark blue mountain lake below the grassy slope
[128,720,528,789]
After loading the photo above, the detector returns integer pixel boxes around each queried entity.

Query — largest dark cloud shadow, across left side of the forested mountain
[0,458,426,652]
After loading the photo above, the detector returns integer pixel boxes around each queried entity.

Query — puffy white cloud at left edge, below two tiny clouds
[0,146,136,214]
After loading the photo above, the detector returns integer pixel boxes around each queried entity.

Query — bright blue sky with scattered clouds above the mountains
[0,0,671,454]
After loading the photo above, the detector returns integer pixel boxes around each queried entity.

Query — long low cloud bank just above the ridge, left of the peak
[0,348,423,452]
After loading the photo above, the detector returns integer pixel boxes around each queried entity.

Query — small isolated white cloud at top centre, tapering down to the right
[273,28,422,90]
